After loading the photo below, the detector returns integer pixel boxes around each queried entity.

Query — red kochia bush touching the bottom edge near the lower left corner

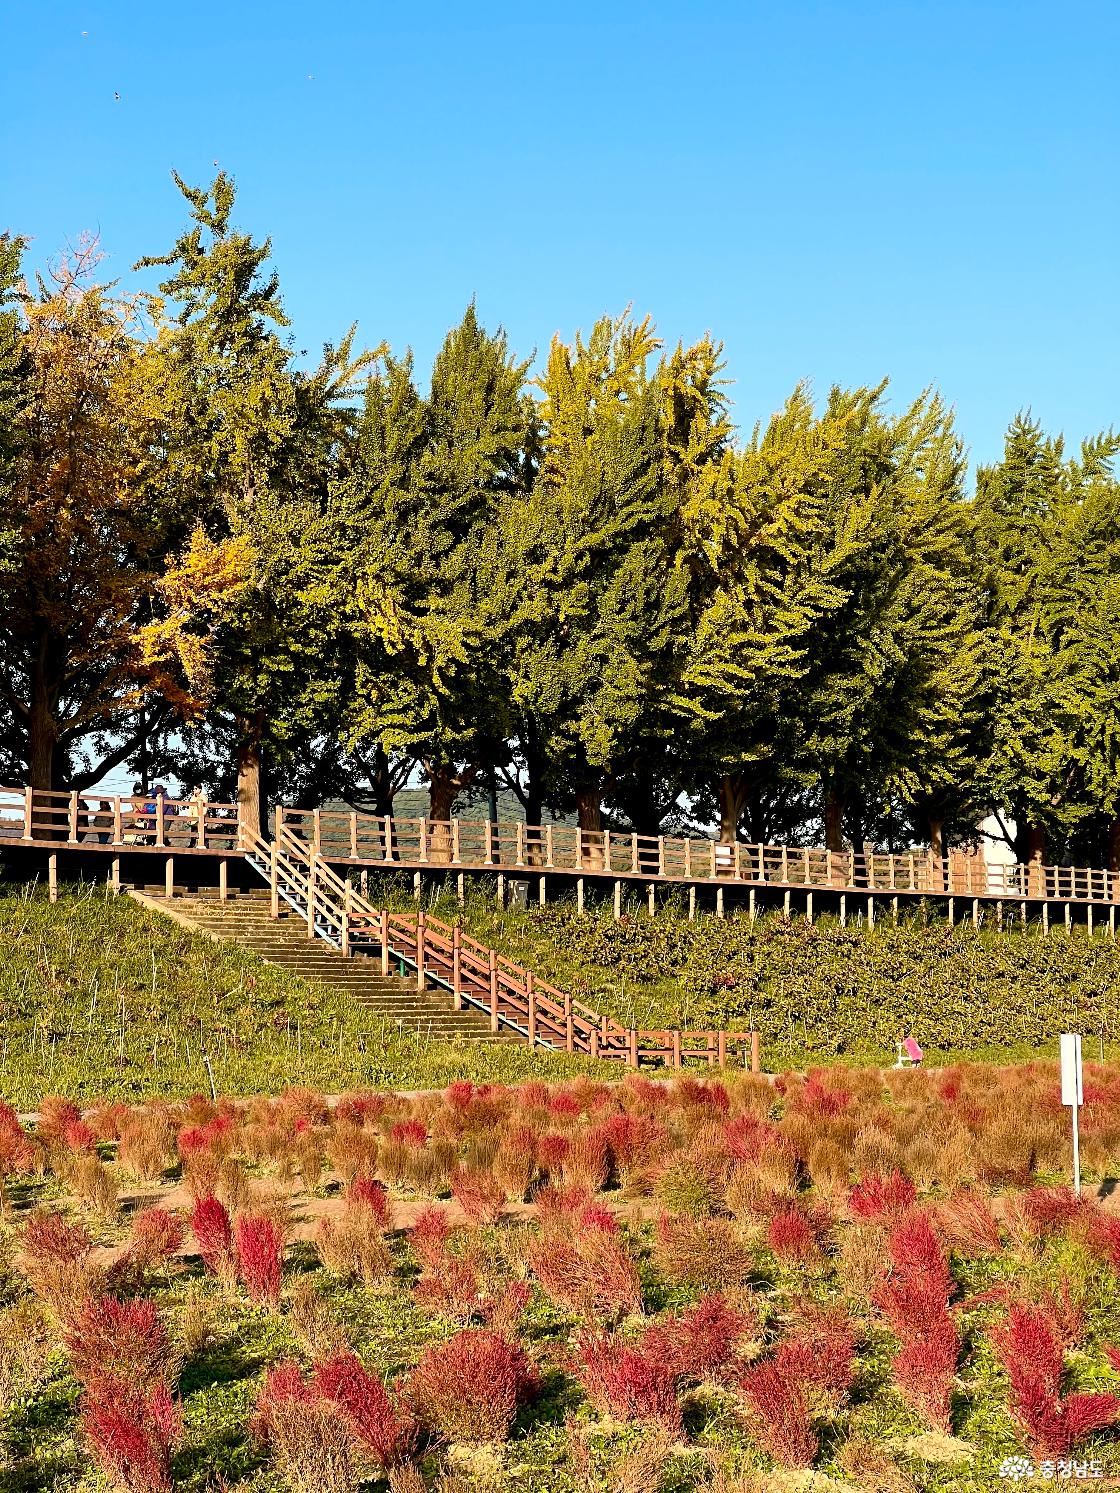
[81,1381,182,1493]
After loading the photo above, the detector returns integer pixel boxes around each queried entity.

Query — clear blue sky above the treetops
[0,0,1120,460]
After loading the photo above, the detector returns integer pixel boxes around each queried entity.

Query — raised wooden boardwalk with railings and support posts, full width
[0,787,1120,932]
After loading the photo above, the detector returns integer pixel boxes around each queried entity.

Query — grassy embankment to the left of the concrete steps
[0,887,591,1108]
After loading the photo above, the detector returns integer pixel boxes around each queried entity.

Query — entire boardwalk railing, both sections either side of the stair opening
[0,787,1120,903]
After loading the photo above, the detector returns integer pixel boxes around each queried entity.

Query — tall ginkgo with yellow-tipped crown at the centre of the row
[502,317,687,830]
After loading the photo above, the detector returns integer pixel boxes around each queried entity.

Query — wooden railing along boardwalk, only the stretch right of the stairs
[278,809,1120,902]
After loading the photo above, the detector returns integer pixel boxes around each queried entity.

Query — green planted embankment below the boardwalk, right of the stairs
[370,878,1120,1069]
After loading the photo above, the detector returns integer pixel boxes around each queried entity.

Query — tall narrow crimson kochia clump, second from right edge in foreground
[875,1214,960,1432]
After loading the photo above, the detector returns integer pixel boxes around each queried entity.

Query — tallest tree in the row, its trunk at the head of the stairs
[137,172,373,829]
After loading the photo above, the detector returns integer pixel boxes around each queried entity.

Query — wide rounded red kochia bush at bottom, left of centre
[409,1327,538,1441]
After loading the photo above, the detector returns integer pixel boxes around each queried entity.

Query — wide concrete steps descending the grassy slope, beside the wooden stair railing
[137,887,511,1042]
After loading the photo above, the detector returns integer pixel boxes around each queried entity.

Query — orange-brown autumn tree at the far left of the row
[0,240,248,790]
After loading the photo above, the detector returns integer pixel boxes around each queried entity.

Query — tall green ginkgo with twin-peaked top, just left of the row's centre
[333,305,530,823]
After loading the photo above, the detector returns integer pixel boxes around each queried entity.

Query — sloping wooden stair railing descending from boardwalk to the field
[253,827,759,1070]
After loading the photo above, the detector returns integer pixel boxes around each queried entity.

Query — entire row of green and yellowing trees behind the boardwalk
[0,175,1120,864]
